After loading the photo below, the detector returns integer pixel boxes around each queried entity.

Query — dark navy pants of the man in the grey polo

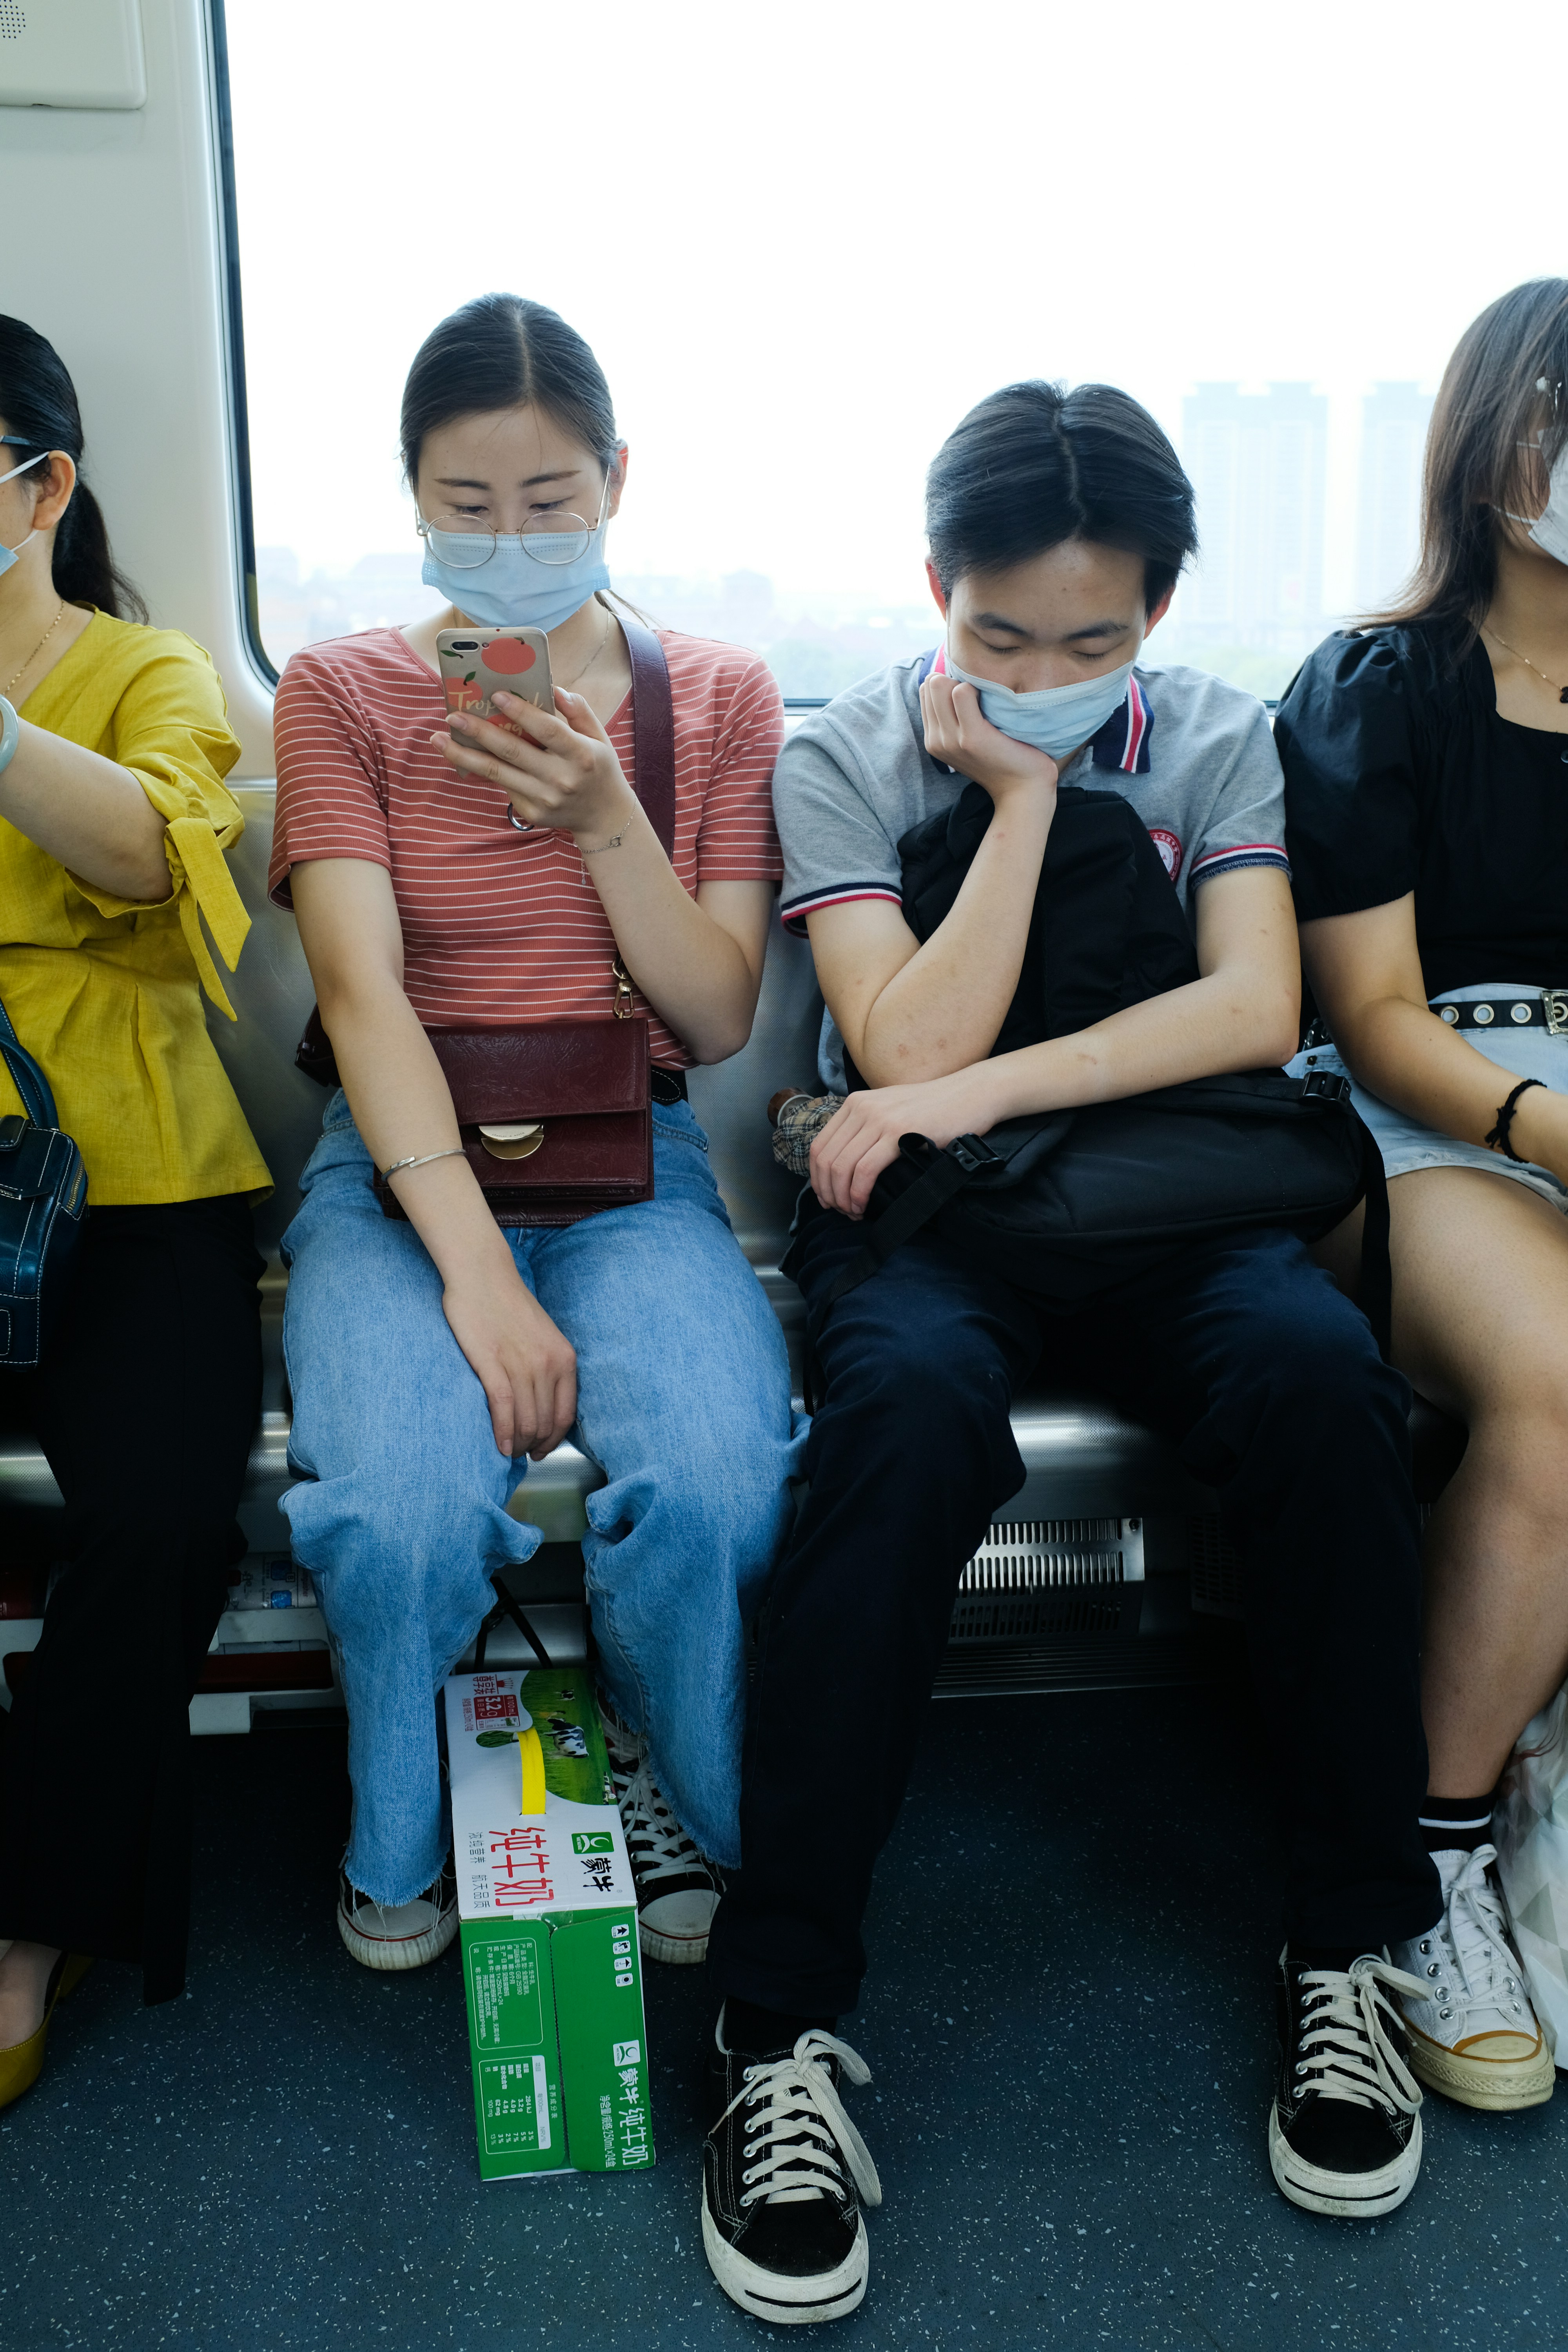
[710,1211,1441,2016]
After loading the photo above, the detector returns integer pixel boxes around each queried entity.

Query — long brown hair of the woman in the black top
[1359,278,1568,659]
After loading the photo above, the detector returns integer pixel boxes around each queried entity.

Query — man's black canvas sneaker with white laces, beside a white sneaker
[1269,1950,1425,2216]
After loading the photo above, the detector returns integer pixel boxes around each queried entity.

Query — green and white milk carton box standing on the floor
[446,1665,653,2180]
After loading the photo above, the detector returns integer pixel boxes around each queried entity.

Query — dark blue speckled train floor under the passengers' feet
[0,1689,1568,2352]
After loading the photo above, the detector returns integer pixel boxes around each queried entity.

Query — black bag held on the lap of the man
[808,783,1389,1355]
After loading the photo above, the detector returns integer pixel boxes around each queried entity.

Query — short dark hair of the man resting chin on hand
[926,383,1199,612]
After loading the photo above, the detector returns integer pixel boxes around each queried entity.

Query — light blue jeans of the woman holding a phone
[282,1094,804,1905]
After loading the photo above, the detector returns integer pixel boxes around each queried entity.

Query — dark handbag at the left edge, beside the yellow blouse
[0,1004,87,1371]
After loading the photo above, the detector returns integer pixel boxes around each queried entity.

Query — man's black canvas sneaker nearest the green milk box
[703,2011,882,2326]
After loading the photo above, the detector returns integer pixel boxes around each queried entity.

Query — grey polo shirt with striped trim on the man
[773,654,1290,1091]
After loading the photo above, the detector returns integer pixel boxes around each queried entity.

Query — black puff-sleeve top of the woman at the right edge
[1274,623,1568,997]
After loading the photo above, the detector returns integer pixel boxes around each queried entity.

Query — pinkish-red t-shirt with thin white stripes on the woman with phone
[268,628,783,1070]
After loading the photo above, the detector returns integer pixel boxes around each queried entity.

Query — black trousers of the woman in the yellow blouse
[0,1195,263,2002]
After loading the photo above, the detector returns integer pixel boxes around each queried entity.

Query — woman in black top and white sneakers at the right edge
[1276,278,1568,2107]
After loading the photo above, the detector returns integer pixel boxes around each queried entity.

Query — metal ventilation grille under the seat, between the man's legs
[947,1519,1143,1642]
